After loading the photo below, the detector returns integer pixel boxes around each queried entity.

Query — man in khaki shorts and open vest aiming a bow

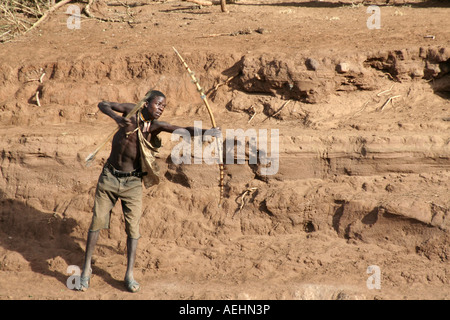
[77,90,217,292]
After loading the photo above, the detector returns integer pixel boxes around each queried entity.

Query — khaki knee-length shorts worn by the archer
[89,167,142,239]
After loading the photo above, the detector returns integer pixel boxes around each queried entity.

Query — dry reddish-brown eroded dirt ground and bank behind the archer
[0,0,450,300]
